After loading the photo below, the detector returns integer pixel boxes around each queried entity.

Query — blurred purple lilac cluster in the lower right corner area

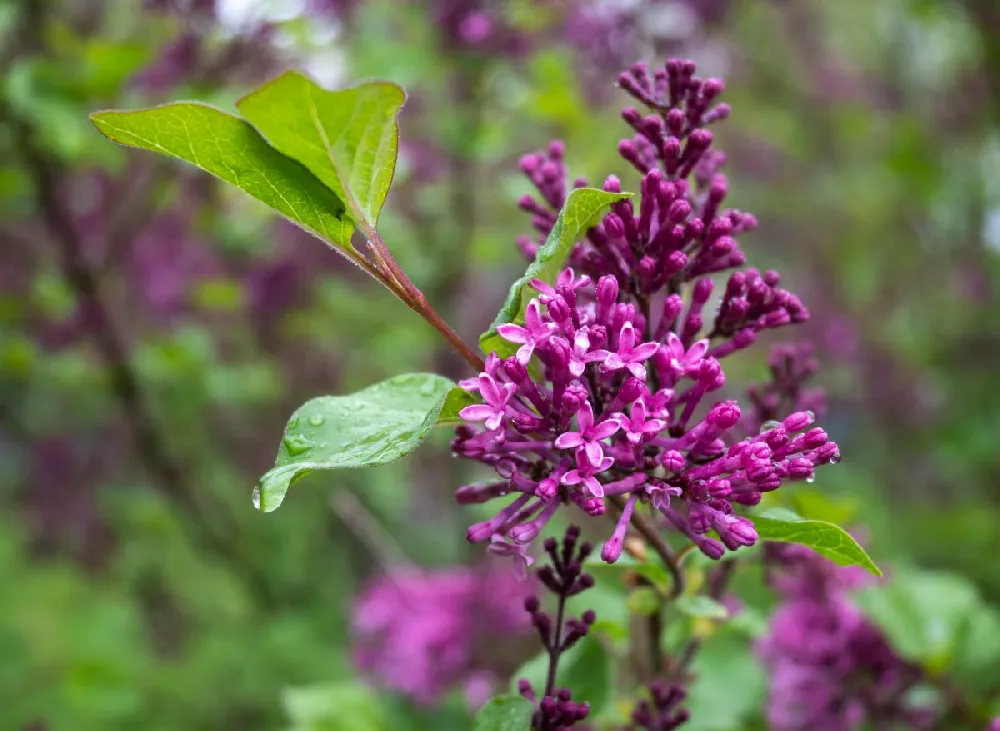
[757,544,936,731]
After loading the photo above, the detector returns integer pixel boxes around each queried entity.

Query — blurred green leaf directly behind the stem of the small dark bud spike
[511,634,614,719]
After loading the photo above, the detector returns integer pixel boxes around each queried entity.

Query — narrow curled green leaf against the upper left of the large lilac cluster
[479,188,632,356]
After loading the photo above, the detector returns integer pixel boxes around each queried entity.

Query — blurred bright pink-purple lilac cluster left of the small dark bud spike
[352,568,531,707]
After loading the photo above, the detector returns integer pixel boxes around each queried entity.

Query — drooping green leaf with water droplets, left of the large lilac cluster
[254,373,457,512]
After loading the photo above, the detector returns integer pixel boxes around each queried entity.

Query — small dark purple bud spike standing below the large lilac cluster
[518,526,597,731]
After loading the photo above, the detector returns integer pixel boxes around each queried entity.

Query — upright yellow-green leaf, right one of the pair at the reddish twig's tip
[236,71,406,236]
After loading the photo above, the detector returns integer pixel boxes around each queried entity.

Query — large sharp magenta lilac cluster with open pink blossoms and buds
[452,59,840,567]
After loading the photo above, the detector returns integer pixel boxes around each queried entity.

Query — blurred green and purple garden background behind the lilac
[0,0,1000,731]
